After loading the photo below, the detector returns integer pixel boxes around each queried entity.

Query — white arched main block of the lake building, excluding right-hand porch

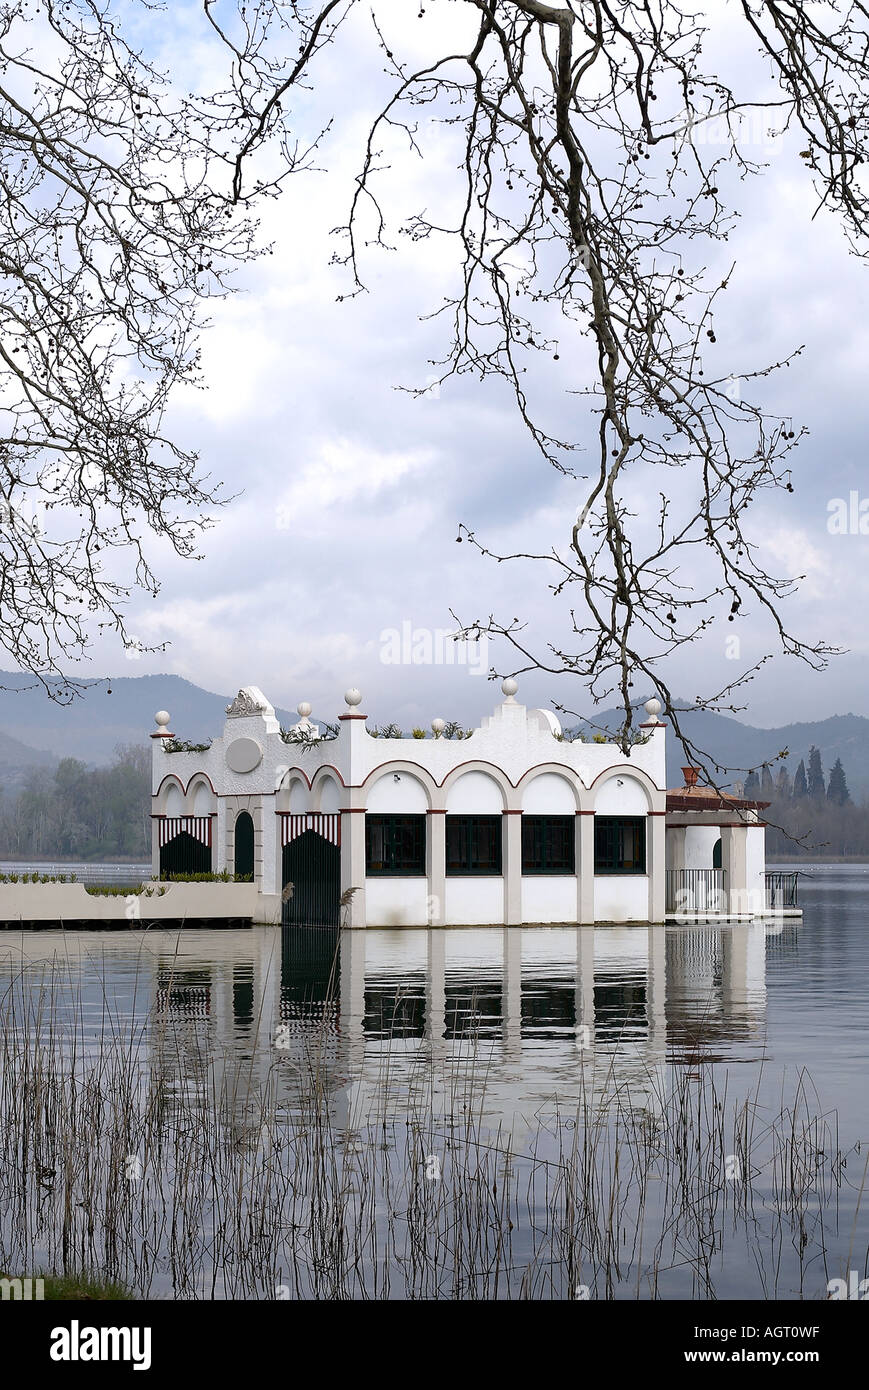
[148,682,681,926]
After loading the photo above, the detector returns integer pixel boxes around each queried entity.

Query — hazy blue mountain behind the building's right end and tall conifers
[578,699,869,798]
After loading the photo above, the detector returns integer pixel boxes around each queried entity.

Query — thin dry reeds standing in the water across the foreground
[0,962,866,1300]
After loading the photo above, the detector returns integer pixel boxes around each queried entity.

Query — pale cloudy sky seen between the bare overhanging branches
[64,0,869,728]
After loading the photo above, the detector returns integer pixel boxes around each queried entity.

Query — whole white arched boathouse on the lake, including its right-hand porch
[152,680,781,927]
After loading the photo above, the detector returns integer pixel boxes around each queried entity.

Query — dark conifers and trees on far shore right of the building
[745,748,869,859]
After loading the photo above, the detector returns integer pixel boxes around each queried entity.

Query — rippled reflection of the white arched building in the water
[140,922,780,1131]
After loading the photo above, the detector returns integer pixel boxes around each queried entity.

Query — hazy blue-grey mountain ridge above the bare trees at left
[0,671,299,774]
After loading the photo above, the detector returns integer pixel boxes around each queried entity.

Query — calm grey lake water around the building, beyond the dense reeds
[0,865,869,1298]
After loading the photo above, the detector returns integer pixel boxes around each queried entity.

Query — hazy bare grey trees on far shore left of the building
[0,744,152,859]
